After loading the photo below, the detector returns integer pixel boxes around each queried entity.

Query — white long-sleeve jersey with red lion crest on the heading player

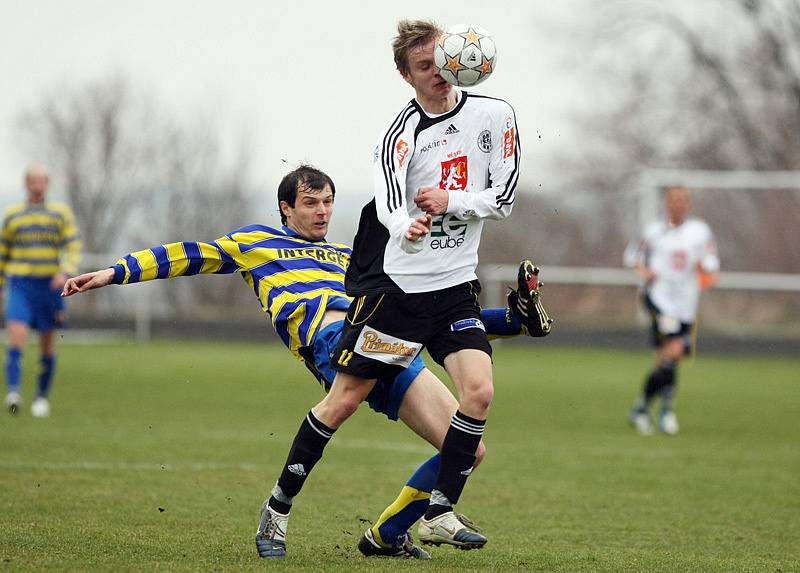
[345,91,520,295]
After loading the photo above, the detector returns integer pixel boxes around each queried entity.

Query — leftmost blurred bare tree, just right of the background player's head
[18,77,164,253]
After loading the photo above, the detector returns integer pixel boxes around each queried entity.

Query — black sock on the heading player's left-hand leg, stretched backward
[269,412,336,513]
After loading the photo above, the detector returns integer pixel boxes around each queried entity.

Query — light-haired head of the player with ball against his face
[392,20,453,99]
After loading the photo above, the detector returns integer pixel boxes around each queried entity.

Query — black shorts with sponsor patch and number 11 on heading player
[331,281,492,378]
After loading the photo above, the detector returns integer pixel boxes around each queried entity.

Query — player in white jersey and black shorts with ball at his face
[262,20,550,556]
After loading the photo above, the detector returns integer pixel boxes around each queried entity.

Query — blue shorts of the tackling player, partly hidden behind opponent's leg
[314,320,425,420]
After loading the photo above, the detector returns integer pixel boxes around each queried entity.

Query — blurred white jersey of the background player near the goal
[624,218,719,323]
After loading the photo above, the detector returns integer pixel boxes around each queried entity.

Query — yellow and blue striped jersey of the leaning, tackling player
[112,225,351,360]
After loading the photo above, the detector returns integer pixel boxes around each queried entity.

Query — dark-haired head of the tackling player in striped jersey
[278,165,336,241]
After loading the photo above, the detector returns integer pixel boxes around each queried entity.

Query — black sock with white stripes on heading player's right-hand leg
[425,411,486,519]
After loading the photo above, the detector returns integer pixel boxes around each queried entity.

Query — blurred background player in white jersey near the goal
[625,187,719,435]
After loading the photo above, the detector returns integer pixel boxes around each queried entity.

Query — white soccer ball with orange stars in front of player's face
[433,24,497,87]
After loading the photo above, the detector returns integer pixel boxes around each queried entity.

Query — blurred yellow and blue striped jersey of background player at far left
[0,201,81,285]
